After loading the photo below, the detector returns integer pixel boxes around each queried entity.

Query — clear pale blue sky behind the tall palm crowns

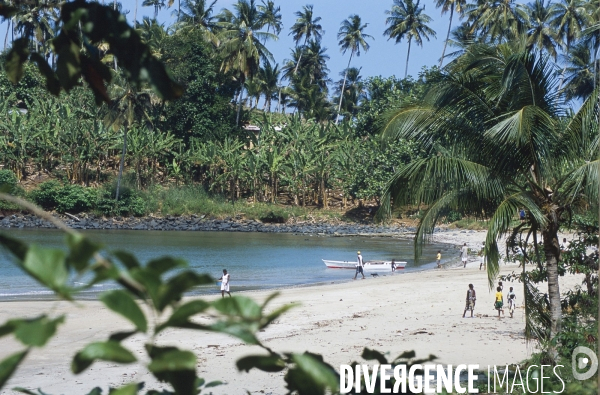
[120,0,460,80]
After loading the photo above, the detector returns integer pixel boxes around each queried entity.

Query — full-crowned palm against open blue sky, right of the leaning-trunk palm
[383,0,435,78]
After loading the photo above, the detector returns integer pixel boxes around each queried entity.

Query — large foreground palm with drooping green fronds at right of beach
[380,43,599,344]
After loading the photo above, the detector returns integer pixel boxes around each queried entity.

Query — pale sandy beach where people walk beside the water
[0,231,581,394]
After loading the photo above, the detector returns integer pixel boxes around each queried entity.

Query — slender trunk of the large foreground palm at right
[542,215,562,338]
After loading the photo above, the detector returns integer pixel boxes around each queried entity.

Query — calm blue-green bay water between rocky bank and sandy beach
[0,229,451,300]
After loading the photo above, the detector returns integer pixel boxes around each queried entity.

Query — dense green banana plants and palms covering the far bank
[0,0,598,214]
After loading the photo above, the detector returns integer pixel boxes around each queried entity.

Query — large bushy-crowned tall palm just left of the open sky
[218,0,277,125]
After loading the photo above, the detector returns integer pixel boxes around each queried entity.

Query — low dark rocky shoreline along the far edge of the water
[0,214,460,236]
